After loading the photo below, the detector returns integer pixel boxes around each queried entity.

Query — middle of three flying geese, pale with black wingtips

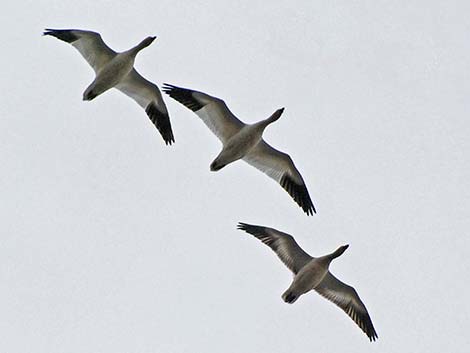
[163,84,316,215]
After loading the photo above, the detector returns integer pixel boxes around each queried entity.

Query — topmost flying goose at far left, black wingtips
[43,29,175,145]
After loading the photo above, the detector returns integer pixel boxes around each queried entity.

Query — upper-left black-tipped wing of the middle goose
[163,83,245,143]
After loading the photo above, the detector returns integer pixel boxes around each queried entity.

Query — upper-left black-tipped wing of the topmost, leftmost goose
[43,28,116,73]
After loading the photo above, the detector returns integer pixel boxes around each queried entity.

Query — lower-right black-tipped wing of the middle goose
[243,140,316,215]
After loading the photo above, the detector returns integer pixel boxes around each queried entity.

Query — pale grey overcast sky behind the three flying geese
[0,0,470,353]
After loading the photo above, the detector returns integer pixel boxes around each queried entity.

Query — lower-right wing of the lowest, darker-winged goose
[315,271,378,341]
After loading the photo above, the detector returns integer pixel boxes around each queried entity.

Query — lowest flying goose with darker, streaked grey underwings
[238,223,378,341]
